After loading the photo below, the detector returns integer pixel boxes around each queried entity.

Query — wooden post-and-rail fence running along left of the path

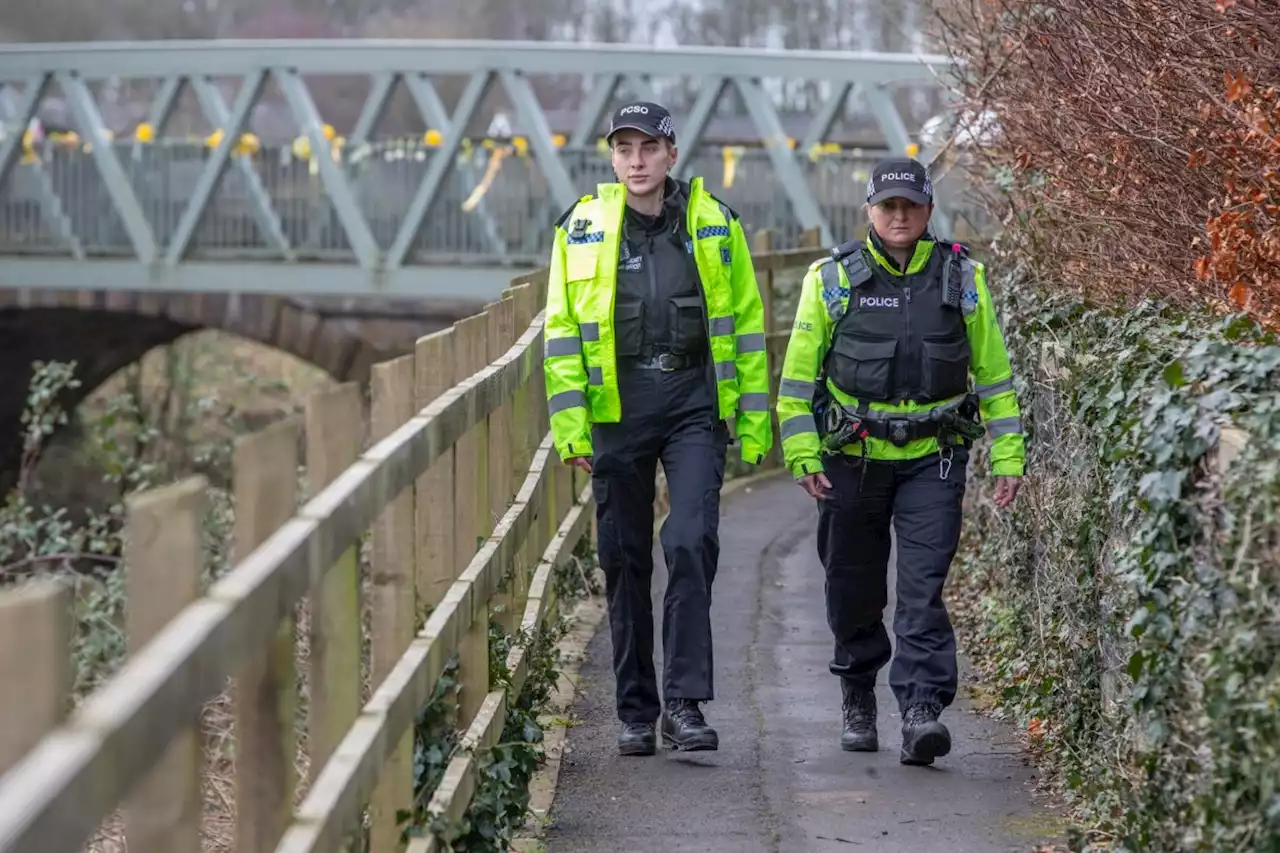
[0,236,820,853]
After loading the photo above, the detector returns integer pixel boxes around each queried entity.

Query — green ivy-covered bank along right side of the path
[951,275,1280,853]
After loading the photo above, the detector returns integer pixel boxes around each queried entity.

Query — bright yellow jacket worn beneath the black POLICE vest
[777,234,1025,478]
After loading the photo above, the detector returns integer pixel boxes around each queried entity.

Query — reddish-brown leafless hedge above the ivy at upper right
[938,0,1280,327]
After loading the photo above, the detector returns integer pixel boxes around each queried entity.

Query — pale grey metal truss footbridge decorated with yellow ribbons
[0,40,955,298]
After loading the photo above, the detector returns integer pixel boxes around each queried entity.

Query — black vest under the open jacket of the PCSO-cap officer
[613,199,709,357]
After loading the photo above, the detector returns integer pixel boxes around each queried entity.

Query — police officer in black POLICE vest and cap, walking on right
[777,159,1024,765]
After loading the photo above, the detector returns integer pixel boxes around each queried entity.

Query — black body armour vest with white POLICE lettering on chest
[822,246,970,403]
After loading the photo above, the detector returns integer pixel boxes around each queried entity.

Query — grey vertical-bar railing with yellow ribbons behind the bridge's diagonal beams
[0,140,885,268]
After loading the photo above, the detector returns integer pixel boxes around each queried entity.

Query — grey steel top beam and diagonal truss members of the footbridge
[0,40,954,296]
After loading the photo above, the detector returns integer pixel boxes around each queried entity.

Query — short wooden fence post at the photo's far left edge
[0,580,76,776]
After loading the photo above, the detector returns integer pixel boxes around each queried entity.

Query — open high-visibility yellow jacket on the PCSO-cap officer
[543,178,773,465]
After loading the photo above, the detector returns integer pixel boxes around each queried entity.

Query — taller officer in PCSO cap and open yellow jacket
[544,102,773,754]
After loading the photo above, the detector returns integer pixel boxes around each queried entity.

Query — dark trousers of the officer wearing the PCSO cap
[591,364,730,722]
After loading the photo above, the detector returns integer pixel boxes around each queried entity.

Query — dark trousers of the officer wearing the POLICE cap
[818,446,969,711]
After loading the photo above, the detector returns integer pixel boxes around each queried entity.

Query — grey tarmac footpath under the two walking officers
[545,478,1056,853]
